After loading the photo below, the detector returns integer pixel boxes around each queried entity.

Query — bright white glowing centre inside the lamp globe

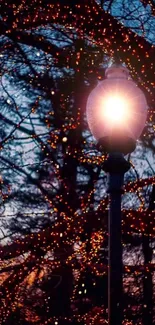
[101,95,129,124]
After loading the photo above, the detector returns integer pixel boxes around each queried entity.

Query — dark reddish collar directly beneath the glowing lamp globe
[97,135,136,155]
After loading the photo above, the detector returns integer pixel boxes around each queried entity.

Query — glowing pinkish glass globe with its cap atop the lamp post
[87,66,147,153]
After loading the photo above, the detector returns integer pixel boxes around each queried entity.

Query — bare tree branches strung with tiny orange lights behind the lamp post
[0,0,155,325]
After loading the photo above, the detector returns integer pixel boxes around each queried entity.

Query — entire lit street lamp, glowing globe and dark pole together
[87,65,147,325]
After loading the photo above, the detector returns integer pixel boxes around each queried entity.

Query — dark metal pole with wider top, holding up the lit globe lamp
[104,153,130,325]
